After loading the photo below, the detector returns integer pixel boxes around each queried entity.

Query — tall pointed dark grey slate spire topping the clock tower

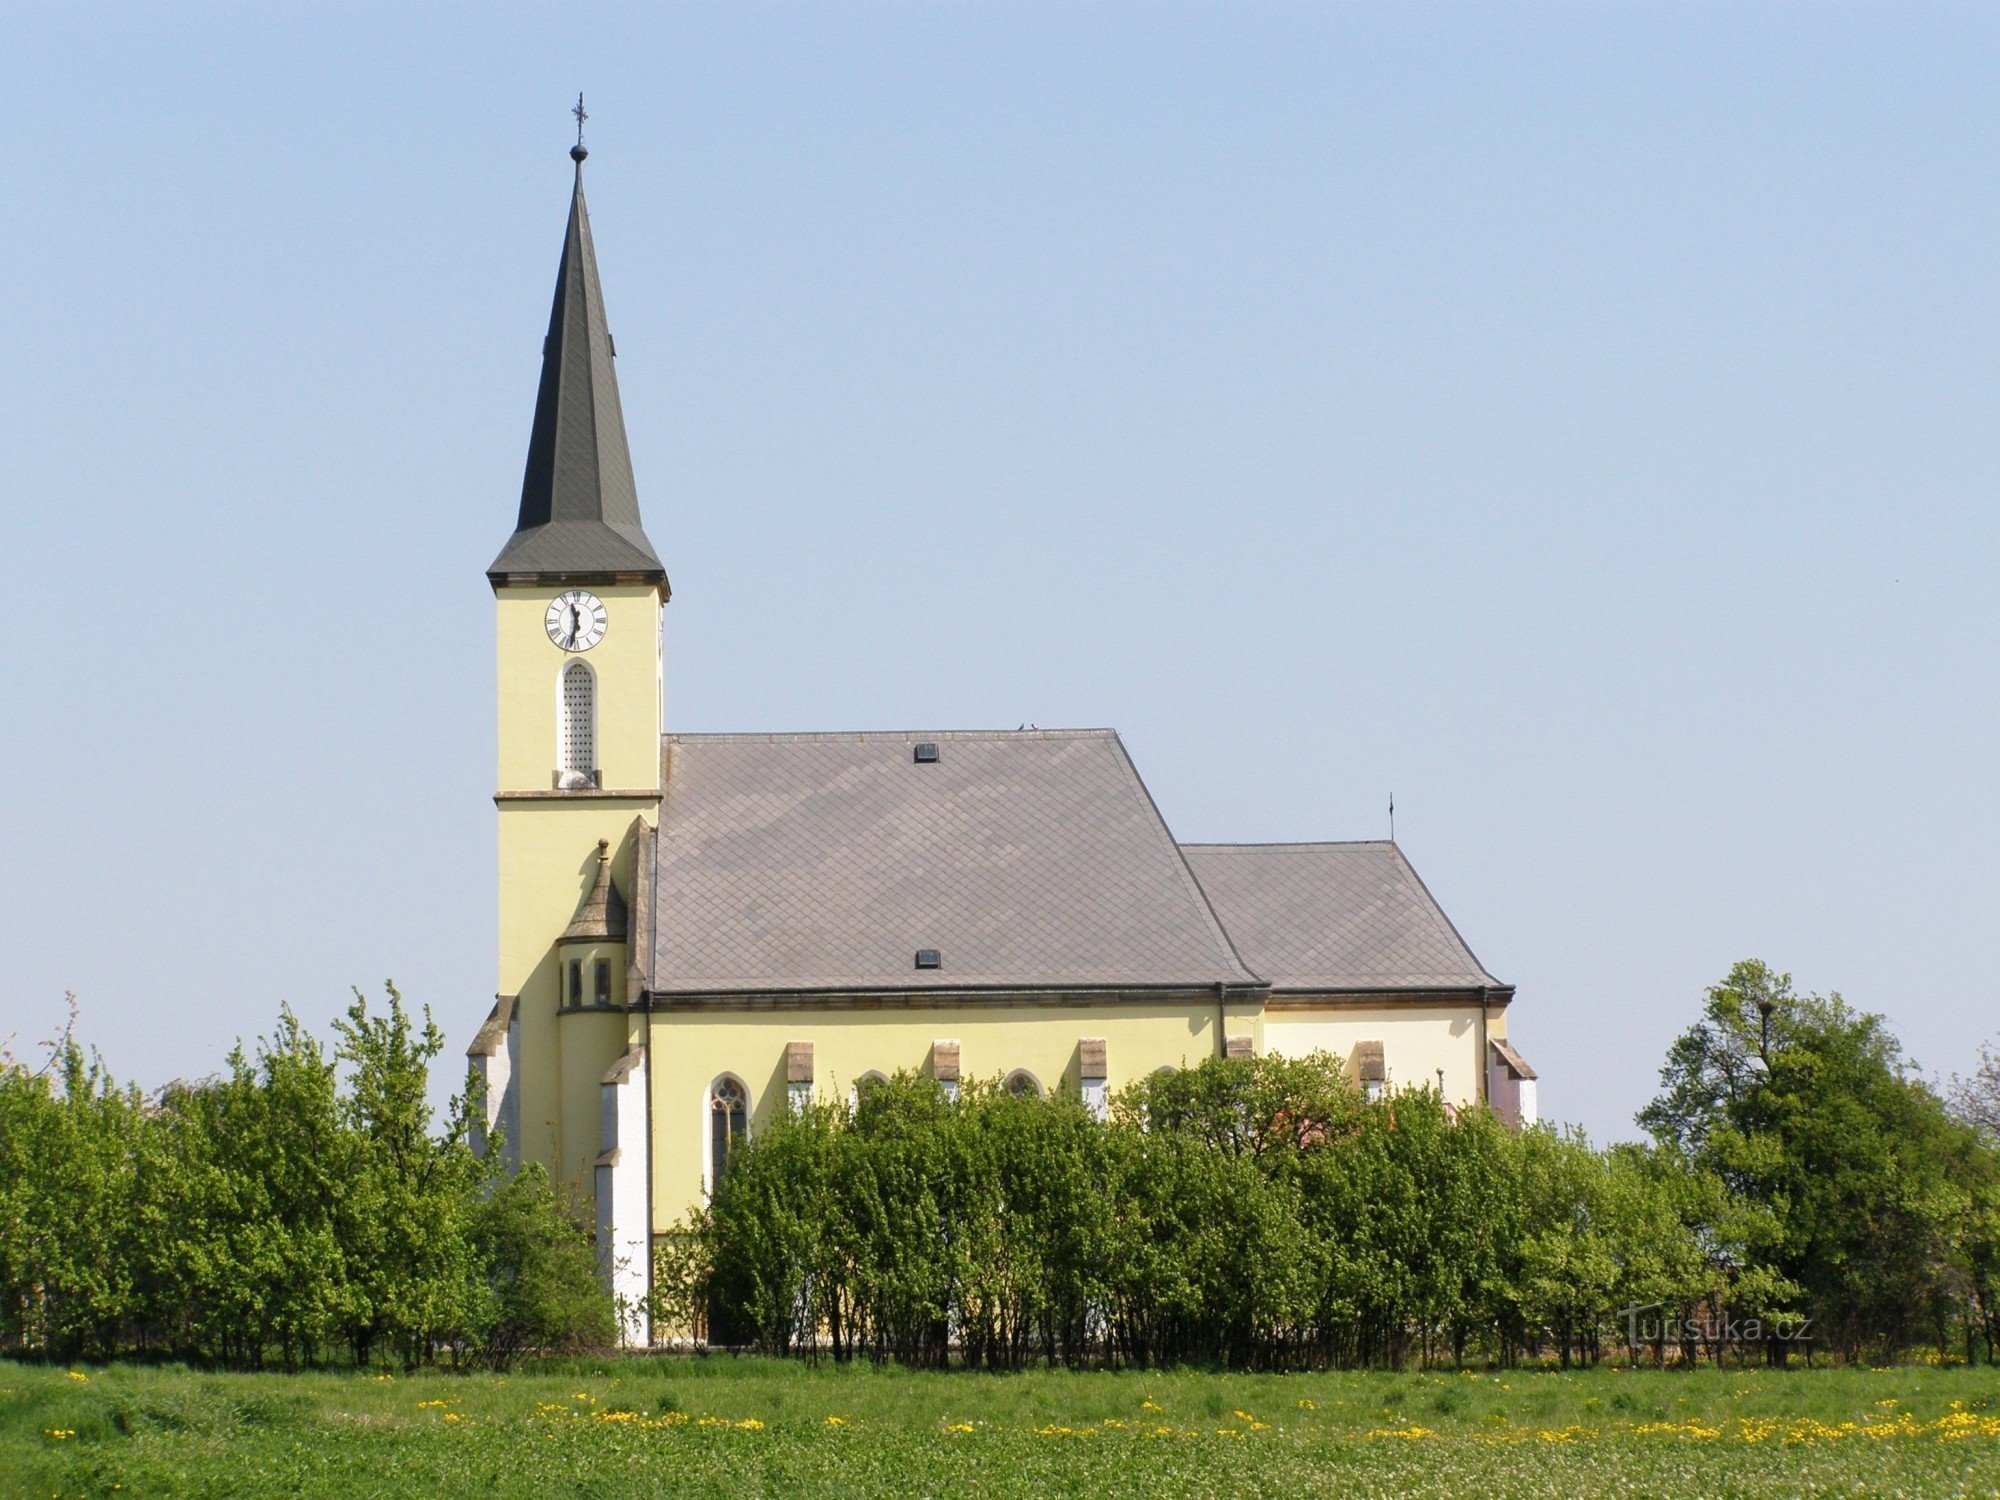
[486,144,666,586]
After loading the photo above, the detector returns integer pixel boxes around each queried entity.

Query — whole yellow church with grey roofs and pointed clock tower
[470,144,1534,1344]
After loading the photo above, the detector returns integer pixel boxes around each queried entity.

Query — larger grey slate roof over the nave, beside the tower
[646,730,1258,994]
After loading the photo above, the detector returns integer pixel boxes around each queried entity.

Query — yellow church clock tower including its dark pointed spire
[472,140,668,1200]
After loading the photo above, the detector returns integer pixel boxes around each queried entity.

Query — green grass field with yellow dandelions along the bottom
[0,1356,2000,1500]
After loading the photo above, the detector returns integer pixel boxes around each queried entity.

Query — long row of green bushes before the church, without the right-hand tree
[656,1056,1712,1370]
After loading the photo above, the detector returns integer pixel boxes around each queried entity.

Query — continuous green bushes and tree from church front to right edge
[672,962,2000,1370]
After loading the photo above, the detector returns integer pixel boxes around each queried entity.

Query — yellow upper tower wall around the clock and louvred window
[494,584,660,792]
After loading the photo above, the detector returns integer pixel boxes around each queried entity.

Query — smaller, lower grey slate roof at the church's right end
[1182,840,1506,994]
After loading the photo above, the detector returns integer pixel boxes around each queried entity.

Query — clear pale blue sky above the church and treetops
[0,4,2000,1136]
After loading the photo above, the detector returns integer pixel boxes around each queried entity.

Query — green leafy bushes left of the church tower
[0,986,612,1368]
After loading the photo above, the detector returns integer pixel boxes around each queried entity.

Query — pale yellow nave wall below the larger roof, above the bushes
[648,1004,1256,1232]
